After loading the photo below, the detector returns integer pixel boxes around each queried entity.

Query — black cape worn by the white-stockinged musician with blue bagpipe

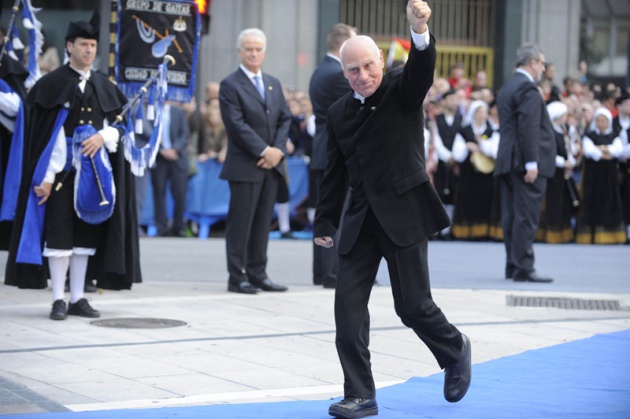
[5,65,142,290]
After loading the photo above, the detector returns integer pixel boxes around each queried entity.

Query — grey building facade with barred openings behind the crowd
[0,0,630,97]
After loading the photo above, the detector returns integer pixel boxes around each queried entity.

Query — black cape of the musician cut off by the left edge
[0,54,28,250]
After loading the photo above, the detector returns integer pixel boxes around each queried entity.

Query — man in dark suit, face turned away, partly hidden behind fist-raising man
[309,23,357,288]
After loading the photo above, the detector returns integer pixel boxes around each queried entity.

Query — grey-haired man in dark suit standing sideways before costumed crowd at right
[494,44,556,282]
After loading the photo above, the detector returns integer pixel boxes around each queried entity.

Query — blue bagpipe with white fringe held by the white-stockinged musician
[55,55,175,224]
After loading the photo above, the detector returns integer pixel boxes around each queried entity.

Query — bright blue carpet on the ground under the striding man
[7,330,630,419]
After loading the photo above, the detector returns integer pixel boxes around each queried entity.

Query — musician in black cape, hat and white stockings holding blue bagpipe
[5,11,142,320]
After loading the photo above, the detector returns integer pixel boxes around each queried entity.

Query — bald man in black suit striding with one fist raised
[314,0,471,418]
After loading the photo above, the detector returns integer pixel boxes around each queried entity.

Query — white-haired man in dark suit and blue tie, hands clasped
[219,28,291,294]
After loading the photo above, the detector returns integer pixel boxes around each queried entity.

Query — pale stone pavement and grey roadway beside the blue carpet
[0,238,630,415]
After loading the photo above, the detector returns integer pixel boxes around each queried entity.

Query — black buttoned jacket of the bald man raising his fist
[314,37,450,254]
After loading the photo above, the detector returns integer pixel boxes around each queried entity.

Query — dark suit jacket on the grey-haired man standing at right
[494,72,556,178]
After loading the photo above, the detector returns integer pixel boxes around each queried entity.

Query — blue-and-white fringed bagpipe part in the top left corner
[0,0,44,89]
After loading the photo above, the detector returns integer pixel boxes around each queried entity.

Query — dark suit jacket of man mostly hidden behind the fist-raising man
[309,55,352,170]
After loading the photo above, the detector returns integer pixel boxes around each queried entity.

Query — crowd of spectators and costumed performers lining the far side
[138,63,630,244]
